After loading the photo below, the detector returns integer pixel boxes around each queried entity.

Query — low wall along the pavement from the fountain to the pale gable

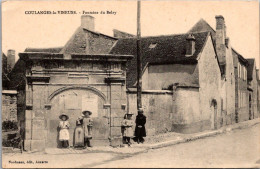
[127,88,206,135]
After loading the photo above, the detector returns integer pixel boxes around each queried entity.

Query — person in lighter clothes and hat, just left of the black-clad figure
[122,113,134,146]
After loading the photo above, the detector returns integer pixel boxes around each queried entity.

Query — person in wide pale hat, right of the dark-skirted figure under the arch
[78,111,93,147]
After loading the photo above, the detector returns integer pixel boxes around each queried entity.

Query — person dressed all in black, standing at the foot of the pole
[135,109,146,144]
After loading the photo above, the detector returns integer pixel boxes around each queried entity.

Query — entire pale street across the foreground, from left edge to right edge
[3,124,260,168]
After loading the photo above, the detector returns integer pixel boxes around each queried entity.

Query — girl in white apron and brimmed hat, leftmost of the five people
[59,114,70,148]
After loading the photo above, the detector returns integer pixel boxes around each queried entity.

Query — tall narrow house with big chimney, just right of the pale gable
[189,15,248,124]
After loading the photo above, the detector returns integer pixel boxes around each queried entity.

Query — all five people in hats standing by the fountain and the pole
[59,109,146,148]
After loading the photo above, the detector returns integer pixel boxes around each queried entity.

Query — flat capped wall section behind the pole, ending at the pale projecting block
[127,90,174,135]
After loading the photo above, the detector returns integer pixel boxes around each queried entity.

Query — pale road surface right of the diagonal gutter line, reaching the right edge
[94,124,260,168]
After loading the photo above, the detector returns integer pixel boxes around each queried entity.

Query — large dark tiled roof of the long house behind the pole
[110,32,209,87]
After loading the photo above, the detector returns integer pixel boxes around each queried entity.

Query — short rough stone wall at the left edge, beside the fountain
[2,90,17,122]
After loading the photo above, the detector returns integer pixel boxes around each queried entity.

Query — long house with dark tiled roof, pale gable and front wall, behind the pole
[110,32,223,134]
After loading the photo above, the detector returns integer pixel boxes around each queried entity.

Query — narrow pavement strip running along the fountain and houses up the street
[2,118,260,155]
